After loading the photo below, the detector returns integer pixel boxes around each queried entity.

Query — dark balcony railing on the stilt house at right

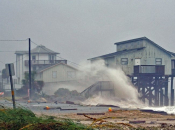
[134,65,165,75]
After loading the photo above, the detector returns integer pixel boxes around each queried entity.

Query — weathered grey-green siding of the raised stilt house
[91,40,172,75]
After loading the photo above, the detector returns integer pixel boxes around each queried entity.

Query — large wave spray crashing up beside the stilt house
[78,60,143,108]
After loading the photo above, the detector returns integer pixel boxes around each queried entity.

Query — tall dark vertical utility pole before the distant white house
[29,38,32,99]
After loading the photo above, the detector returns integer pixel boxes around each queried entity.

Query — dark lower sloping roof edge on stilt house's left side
[88,47,145,60]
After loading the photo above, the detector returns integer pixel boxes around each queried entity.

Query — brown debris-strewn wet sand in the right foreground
[38,110,175,130]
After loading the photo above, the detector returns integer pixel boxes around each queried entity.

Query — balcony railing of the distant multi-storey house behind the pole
[25,60,67,66]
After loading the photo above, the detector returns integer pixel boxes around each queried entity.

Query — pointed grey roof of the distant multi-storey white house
[15,45,59,55]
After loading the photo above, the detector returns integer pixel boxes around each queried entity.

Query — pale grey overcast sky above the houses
[0,0,175,68]
